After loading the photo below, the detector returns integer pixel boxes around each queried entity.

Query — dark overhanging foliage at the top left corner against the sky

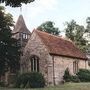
[0,0,35,7]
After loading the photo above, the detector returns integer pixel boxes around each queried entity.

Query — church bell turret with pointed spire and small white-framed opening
[12,15,31,47]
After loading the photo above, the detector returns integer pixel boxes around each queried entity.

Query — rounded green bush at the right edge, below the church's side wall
[77,69,90,82]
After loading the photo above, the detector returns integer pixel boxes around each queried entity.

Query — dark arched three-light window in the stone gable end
[30,55,39,72]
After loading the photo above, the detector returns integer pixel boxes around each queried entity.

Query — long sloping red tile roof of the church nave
[35,30,87,59]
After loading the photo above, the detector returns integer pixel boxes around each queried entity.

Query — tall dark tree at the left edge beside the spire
[0,6,20,76]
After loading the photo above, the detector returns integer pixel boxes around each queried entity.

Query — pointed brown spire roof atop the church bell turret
[12,15,30,34]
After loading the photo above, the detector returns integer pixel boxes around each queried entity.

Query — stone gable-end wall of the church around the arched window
[21,33,52,85]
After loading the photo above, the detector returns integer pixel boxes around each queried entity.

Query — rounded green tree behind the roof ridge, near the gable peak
[37,21,60,35]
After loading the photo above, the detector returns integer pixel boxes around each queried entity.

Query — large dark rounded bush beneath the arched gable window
[15,72,45,88]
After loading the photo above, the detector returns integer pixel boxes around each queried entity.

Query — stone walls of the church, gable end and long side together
[21,32,88,85]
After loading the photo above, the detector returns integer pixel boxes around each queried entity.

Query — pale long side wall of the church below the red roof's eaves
[54,56,88,84]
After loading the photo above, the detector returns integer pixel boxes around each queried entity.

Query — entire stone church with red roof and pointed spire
[12,15,89,85]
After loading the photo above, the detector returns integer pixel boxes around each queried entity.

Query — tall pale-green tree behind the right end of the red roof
[65,20,88,52]
